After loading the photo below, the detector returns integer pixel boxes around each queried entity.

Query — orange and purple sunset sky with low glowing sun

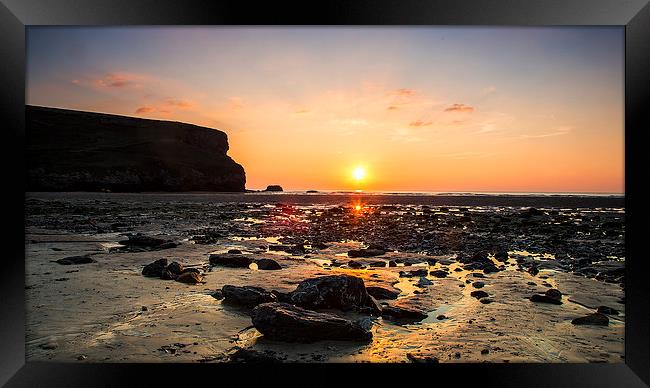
[27,27,624,193]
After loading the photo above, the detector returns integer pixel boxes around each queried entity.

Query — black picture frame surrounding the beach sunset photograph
[0,0,650,387]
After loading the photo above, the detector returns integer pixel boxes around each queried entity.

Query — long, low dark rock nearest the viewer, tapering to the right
[251,302,372,342]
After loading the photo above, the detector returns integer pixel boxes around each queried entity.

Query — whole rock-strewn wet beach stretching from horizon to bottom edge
[25,192,626,363]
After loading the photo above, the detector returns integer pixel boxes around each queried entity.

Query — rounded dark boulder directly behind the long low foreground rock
[291,275,380,313]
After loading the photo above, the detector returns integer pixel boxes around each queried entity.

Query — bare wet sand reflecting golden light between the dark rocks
[25,196,625,362]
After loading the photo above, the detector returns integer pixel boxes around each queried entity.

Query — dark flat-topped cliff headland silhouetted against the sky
[25,105,246,192]
